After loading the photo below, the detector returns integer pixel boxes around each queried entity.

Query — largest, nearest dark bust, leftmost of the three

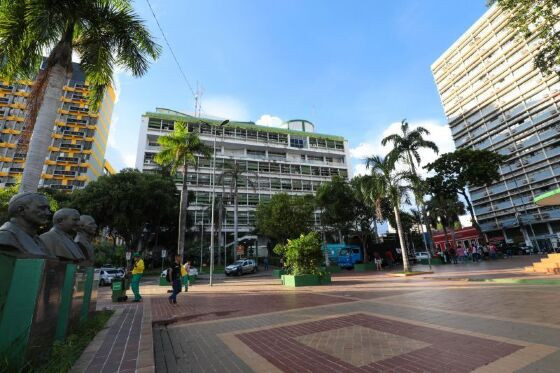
[0,193,52,258]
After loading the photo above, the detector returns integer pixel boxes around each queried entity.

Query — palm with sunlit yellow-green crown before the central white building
[154,122,211,255]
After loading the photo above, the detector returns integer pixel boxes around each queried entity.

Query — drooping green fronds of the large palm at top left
[0,0,160,107]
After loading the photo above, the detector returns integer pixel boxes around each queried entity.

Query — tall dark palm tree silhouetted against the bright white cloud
[381,119,439,251]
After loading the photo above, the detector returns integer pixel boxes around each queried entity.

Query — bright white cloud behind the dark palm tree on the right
[350,120,455,175]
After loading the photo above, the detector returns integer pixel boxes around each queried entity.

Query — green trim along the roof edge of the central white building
[143,111,344,141]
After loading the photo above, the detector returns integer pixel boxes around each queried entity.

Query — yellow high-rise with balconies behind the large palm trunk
[0,63,115,191]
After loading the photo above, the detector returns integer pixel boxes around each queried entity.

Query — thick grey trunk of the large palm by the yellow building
[19,64,68,193]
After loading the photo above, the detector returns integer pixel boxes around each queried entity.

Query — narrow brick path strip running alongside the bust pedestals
[85,303,143,373]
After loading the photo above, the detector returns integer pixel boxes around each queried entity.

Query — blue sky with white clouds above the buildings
[106,0,486,174]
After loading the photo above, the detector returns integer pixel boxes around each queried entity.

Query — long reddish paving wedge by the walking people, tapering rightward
[152,292,353,325]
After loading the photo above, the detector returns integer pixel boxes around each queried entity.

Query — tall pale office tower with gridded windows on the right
[432,6,560,247]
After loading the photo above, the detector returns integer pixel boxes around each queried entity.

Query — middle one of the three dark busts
[40,208,86,262]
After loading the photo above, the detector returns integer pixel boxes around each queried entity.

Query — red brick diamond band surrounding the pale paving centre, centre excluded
[236,314,523,372]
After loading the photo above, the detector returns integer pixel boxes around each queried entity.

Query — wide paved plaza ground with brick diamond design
[77,256,560,372]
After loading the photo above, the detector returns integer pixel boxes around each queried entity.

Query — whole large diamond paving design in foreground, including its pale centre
[237,314,522,372]
